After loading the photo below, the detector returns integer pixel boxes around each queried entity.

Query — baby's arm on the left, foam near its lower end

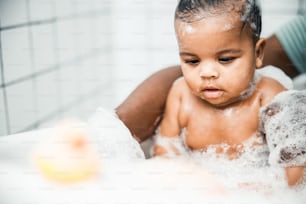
[153,81,182,156]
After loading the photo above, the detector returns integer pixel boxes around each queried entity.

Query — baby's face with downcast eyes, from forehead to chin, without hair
[175,14,263,105]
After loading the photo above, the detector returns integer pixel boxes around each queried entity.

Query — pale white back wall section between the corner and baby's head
[112,0,179,105]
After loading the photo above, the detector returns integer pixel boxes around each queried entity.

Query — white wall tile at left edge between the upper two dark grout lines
[1,27,33,82]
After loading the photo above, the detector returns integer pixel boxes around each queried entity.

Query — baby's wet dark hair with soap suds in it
[175,0,261,41]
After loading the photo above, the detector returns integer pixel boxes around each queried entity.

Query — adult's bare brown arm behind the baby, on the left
[116,66,182,142]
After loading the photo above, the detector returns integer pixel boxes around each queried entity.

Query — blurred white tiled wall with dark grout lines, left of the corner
[0,0,114,135]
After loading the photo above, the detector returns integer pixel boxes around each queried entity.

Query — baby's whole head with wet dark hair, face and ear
[175,0,265,107]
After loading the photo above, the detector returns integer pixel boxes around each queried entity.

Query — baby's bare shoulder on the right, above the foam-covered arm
[257,76,287,105]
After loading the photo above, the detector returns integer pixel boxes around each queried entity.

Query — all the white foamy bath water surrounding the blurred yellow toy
[0,106,306,204]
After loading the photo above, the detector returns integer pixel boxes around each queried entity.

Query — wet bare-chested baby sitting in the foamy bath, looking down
[153,0,302,185]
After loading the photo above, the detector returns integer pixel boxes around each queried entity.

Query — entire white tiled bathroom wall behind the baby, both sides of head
[0,0,306,135]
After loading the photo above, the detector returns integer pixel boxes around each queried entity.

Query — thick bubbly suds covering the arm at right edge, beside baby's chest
[259,90,306,167]
